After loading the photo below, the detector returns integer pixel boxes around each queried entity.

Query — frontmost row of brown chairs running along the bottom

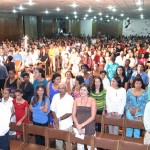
[10,123,150,150]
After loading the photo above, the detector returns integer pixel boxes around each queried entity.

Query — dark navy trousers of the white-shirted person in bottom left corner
[0,132,10,150]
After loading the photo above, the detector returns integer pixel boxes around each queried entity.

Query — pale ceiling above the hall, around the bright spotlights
[0,0,150,19]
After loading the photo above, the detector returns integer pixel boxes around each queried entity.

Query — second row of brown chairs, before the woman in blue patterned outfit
[95,113,145,144]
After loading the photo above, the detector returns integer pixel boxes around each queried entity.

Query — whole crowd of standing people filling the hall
[0,36,150,150]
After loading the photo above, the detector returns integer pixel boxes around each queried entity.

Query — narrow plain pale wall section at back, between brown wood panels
[80,20,92,36]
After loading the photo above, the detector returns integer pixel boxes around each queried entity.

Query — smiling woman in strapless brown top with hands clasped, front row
[72,84,97,150]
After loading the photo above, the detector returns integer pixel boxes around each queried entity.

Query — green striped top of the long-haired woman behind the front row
[90,90,106,111]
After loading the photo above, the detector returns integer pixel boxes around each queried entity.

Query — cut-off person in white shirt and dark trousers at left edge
[0,103,11,150]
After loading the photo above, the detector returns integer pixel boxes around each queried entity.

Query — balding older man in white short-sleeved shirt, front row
[51,83,74,150]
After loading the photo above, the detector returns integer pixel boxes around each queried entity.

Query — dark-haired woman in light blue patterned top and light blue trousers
[126,76,148,138]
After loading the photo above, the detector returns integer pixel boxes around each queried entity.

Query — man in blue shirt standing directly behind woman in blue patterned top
[130,63,149,86]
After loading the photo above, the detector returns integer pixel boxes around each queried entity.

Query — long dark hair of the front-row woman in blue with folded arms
[32,84,47,106]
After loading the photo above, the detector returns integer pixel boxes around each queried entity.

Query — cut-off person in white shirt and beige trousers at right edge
[144,102,150,145]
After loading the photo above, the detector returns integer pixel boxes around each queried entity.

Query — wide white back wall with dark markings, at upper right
[123,19,150,36]
